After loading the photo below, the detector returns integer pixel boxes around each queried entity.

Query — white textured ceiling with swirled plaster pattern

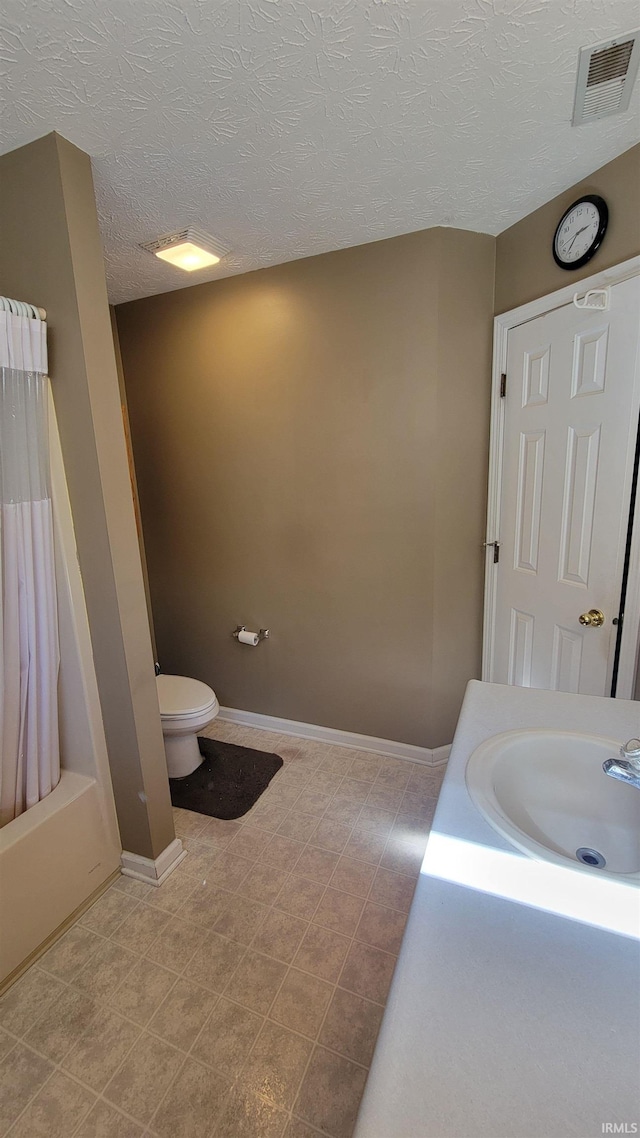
[2,0,640,303]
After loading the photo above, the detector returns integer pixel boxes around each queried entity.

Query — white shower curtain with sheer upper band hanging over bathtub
[0,311,60,826]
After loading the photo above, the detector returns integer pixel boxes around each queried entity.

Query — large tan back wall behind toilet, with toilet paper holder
[116,230,494,747]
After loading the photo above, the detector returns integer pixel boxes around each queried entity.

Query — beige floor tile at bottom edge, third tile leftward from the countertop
[153,1058,229,1138]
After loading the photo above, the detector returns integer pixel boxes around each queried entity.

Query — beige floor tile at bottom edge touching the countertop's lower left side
[295,1047,367,1138]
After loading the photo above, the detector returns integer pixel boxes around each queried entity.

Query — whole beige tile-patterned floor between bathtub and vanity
[0,723,442,1138]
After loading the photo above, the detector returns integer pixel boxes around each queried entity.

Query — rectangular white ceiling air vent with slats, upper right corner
[572,32,640,126]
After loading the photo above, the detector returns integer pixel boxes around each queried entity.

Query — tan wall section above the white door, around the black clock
[495,146,640,313]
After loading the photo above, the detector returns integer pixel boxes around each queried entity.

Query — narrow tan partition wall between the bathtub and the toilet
[0,134,174,858]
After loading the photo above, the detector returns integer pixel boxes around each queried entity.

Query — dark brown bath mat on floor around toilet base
[169,735,282,818]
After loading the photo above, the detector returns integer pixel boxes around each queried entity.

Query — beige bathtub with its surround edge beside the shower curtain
[0,398,122,988]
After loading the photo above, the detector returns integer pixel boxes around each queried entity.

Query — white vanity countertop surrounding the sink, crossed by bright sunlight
[354,681,640,1138]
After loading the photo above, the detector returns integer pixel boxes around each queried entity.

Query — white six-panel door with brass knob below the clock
[491,277,640,695]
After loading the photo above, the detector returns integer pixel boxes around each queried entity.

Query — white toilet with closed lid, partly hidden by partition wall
[156,675,220,778]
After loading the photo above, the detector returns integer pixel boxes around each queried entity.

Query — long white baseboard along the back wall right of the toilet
[219,707,451,767]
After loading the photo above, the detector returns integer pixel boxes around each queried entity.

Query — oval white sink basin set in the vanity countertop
[467,729,640,880]
